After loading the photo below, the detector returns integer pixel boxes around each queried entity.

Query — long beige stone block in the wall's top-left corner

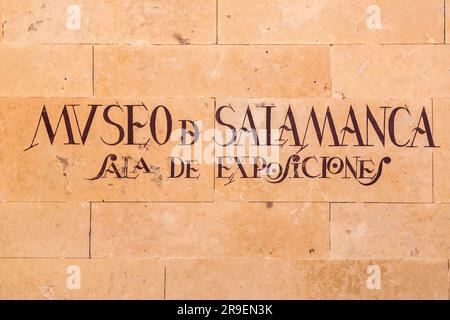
[0,0,216,44]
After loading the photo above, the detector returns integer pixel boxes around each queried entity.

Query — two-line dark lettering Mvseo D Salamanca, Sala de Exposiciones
[25,103,438,186]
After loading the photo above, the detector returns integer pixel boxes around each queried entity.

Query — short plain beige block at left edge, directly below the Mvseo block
[0,203,89,258]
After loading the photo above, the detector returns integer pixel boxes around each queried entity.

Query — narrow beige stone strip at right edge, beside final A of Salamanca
[433,100,450,202]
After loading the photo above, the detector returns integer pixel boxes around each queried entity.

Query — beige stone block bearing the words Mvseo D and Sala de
[0,98,214,201]
